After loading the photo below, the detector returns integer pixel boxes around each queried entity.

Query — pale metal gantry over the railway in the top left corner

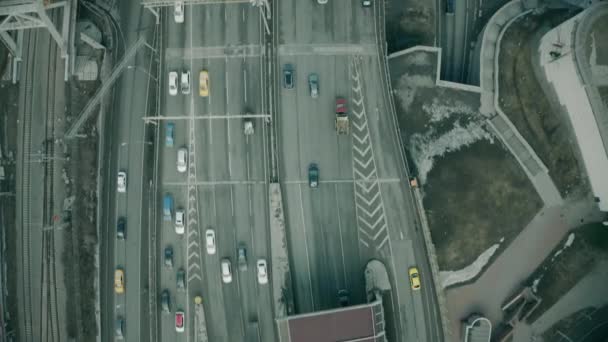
[0,0,71,61]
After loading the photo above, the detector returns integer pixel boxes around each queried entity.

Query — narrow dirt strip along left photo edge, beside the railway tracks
[0,79,19,341]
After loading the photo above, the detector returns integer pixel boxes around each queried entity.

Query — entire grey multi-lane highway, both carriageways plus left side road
[102,0,441,341]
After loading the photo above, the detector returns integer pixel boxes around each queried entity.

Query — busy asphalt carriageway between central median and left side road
[157,4,276,341]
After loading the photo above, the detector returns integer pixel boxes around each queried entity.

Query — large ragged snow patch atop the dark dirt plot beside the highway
[410,121,494,184]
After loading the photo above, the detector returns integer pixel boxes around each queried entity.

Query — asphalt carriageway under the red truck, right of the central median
[276,0,441,341]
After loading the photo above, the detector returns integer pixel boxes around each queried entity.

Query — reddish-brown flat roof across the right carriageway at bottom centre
[277,301,385,342]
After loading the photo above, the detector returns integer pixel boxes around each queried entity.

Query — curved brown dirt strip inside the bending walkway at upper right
[499,11,588,197]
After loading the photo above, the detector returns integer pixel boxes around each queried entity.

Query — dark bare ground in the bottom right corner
[543,306,608,342]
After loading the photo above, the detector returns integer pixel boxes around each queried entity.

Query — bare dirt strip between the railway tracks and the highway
[62,81,99,341]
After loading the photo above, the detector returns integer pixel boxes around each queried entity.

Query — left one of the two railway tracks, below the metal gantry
[17,31,38,342]
